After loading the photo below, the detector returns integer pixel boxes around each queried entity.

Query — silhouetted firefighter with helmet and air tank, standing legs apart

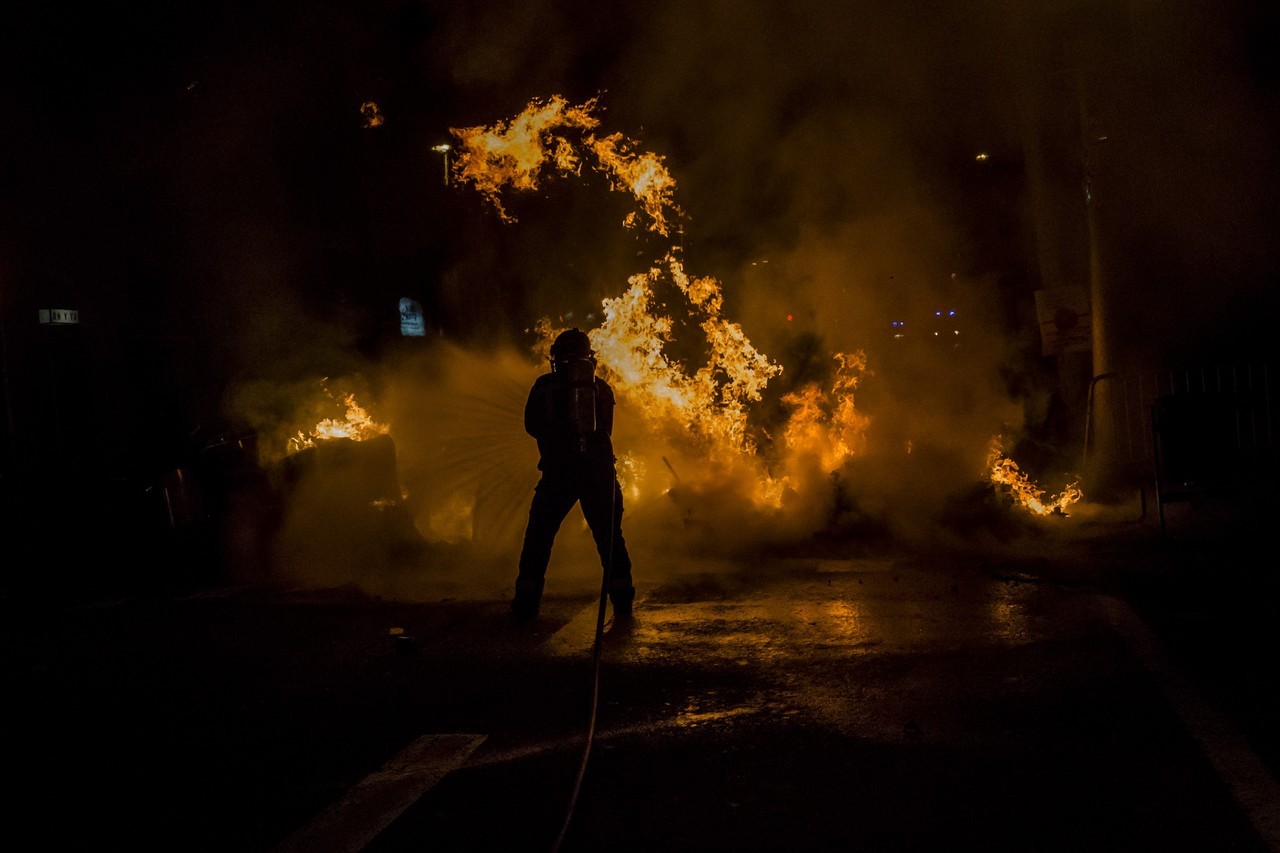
[511,328,636,619]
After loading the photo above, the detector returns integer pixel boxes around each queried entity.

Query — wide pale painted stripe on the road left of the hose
[275,734,485,853]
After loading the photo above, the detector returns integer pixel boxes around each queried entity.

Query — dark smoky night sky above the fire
[0,0,1280,494]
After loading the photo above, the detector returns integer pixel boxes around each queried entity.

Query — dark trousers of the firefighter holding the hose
[516,465,635,611]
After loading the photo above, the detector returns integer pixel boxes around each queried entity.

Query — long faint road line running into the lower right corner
[1103,597,1280,853]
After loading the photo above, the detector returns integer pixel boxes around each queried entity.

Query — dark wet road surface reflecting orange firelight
[4,494,1280,853]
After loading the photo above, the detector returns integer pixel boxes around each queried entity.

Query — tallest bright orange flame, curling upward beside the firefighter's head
[452,95,782,471]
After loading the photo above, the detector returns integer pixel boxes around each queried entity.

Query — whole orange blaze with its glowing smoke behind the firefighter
[225,95,1082,596]
